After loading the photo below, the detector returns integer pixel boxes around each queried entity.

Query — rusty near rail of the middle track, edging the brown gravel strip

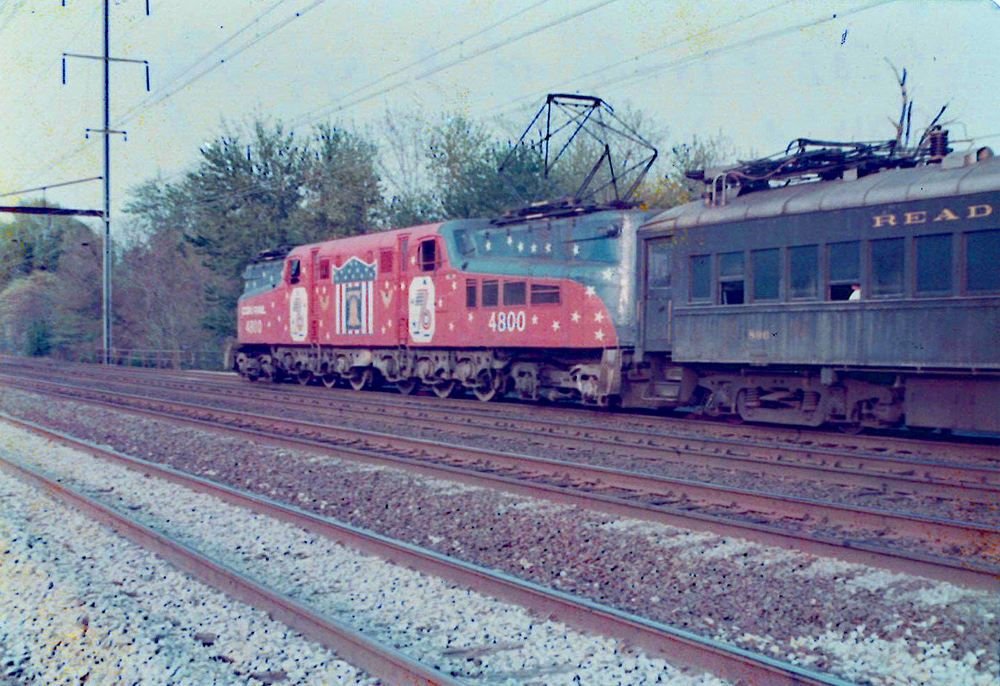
[3,382,1000,590]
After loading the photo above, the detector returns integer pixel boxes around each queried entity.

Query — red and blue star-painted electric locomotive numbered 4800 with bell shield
[232,203,651,405]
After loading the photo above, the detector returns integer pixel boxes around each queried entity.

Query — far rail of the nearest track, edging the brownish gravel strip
[0,415,853,686]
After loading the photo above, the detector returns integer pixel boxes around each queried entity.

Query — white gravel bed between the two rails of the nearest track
[0,427,725,686]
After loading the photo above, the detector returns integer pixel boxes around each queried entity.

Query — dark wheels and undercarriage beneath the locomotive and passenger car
[231,345,1000,432]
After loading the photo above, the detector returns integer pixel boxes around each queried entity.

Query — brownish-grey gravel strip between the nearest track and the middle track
[0,390,998,686]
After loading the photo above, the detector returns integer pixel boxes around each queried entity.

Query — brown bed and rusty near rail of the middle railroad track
[3,368,1000,588]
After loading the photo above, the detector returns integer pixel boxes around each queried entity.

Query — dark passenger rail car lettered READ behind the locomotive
[629,149,1000,432]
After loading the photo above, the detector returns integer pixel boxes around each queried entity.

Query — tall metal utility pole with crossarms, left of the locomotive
[63,0,149,364]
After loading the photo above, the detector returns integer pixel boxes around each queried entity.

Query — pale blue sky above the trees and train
[0,0,1000,232]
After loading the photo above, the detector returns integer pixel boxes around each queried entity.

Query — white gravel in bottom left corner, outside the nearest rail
[0,476,378,686]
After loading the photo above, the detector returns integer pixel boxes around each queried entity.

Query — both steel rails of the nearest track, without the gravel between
[0,418,850,686]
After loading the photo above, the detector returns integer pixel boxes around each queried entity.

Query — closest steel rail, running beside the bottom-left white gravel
[0,452,469,686]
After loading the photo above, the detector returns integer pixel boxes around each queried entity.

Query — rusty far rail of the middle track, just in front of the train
[0,370,1000,504]
